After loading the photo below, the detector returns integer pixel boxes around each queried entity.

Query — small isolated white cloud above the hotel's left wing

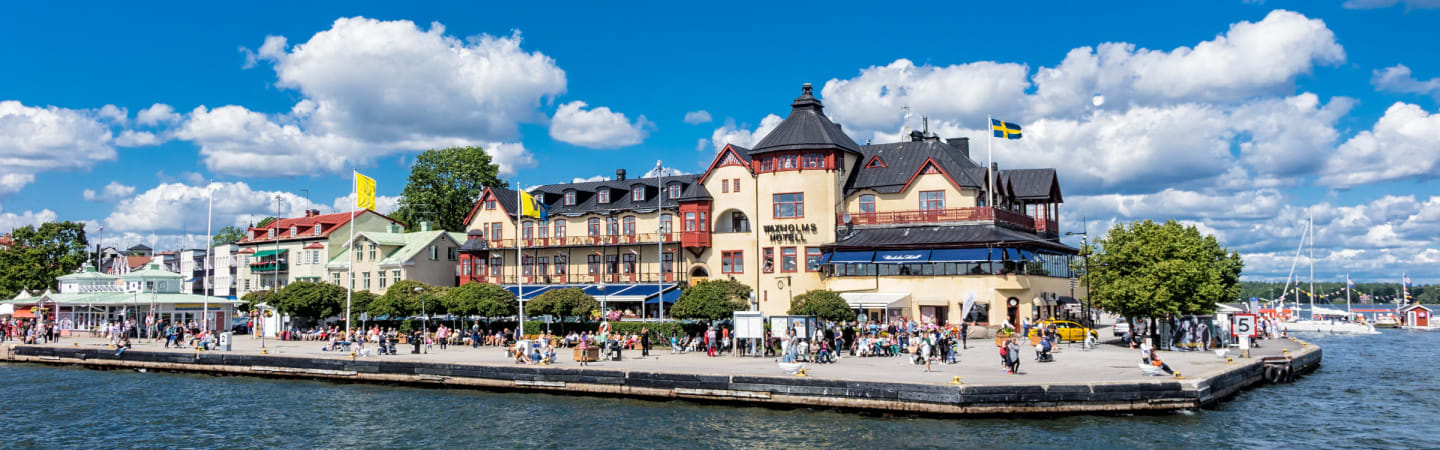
[550,101,651,149]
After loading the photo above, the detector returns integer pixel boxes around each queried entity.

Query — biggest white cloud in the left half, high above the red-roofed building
[188,17,566,176]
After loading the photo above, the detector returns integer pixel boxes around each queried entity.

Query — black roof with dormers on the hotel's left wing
[530,175,710,215]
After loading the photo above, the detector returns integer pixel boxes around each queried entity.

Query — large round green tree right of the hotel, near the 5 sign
[1090,219,1244,343]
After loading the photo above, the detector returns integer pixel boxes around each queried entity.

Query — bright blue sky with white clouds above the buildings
[0,0,1440,283]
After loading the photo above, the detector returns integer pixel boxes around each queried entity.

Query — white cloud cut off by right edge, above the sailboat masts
[1319,102,1440,188]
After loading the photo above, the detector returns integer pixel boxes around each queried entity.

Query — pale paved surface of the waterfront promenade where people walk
[36,331,1300,385]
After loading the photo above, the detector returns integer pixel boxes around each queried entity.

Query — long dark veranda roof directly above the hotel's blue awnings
[824,225,1079,254]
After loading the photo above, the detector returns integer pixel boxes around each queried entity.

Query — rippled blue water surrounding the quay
[0,330,1440,449]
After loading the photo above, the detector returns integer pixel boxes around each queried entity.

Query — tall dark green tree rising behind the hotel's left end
[395,147,505,231]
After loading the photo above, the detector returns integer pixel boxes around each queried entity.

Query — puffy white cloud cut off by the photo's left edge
[0,101,115,195]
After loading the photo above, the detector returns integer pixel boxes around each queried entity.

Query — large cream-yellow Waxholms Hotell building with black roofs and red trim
[456,84,1083,327]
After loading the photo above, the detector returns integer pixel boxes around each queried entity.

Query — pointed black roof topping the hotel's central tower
[749,82,860,154]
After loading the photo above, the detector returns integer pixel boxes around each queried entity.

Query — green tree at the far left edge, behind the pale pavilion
[0,222,89,299]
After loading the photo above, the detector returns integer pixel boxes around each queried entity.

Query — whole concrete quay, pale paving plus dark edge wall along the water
[0,339,1322,415]
